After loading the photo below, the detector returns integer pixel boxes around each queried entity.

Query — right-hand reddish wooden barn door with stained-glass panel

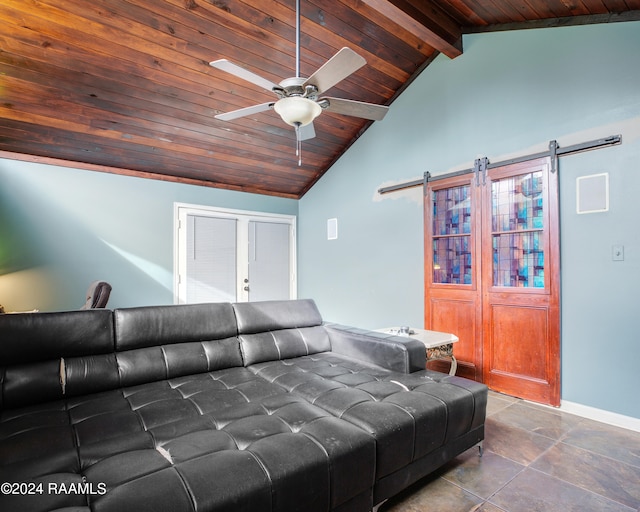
[482,158,560,405]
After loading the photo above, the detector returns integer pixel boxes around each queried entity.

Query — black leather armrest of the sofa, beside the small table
[324,324,427,373]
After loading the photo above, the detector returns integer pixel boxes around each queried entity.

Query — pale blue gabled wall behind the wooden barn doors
[299,22,640,418]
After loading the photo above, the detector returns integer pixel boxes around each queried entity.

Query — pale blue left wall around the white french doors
[0,159,298,311]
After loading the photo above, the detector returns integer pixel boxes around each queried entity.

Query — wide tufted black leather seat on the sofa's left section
[0,367,375,512]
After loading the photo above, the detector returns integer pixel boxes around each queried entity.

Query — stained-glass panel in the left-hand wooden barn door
[432,185,473,284]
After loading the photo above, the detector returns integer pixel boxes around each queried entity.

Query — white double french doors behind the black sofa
[174,204,296,304]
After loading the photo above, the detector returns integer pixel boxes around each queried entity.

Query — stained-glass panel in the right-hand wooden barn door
[491,171,545,288]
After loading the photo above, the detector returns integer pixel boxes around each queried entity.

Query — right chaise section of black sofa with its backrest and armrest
[233,301,487,504]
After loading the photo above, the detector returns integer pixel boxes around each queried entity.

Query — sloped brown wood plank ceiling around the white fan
[0,0,640,198]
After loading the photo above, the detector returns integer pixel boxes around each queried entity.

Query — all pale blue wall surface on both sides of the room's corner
[0,22,640,418]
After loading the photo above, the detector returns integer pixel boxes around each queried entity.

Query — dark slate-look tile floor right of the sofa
[379,392,640,512]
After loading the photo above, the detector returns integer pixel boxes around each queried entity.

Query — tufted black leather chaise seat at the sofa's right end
[249,353,486,479]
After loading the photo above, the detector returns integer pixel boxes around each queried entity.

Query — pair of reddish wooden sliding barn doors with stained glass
[425,158,560,405]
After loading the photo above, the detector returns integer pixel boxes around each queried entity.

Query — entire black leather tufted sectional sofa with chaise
[0,300,487,512]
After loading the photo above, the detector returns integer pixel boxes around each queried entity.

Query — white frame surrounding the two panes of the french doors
[173,203,298,304]
